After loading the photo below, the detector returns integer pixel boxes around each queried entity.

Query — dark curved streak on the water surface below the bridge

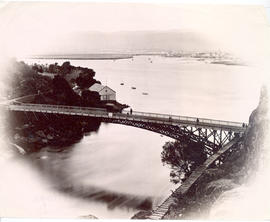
[27,144,153,210]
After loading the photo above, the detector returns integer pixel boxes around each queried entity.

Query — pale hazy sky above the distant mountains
[0,2,269,60]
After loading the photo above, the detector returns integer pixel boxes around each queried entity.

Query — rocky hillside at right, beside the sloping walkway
[132,87,270,220]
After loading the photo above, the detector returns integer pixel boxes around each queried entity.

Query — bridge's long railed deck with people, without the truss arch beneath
[5,103,246,133]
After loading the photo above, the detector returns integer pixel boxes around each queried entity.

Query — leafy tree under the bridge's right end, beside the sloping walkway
[161,139,207,183]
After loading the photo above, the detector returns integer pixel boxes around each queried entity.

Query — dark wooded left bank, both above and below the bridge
[5,61,126,153]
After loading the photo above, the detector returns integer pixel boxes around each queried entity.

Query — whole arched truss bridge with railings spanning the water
[5,103,247,154]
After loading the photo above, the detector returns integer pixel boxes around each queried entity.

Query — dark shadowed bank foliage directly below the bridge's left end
[6,112,100,153]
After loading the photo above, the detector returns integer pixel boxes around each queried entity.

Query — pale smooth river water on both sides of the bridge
[0,56,261,219]
